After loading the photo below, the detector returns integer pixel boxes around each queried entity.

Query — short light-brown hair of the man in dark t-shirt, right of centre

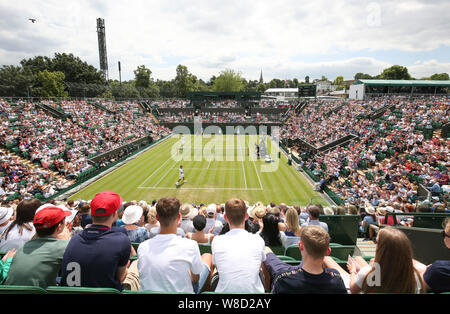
[300,225,330,259]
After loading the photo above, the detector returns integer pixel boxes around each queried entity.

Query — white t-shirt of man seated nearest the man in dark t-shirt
[211,229,266,293]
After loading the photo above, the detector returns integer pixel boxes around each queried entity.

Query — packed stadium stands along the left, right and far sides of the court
[0,97,450,294]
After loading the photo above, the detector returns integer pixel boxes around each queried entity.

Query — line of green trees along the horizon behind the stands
[0,53,449,99]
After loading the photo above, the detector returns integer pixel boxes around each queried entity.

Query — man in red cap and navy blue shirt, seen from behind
[61,191,131,291]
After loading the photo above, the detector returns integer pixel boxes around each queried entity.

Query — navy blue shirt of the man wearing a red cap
[61,225,131,291]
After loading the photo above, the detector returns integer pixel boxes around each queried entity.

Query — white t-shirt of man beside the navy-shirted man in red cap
[137,234,204,293]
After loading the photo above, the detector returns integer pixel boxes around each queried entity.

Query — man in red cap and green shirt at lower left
[4,204,71,288]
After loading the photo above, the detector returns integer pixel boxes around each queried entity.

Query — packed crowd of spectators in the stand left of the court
[0,100,170,198]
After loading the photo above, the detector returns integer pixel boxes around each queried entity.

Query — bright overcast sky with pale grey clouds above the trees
[0,0,450,82]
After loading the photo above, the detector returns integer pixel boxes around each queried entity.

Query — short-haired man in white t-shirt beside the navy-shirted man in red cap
[138,197,212,293]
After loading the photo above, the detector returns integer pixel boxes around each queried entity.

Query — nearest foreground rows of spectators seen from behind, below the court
[0,191,450,294]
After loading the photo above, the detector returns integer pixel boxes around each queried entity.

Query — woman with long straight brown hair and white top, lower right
[362,227,424,293]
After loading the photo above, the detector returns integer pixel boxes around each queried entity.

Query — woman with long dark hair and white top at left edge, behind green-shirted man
[0,198,42,252]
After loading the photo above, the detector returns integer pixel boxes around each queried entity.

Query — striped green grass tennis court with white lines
[70,135,328,205]
